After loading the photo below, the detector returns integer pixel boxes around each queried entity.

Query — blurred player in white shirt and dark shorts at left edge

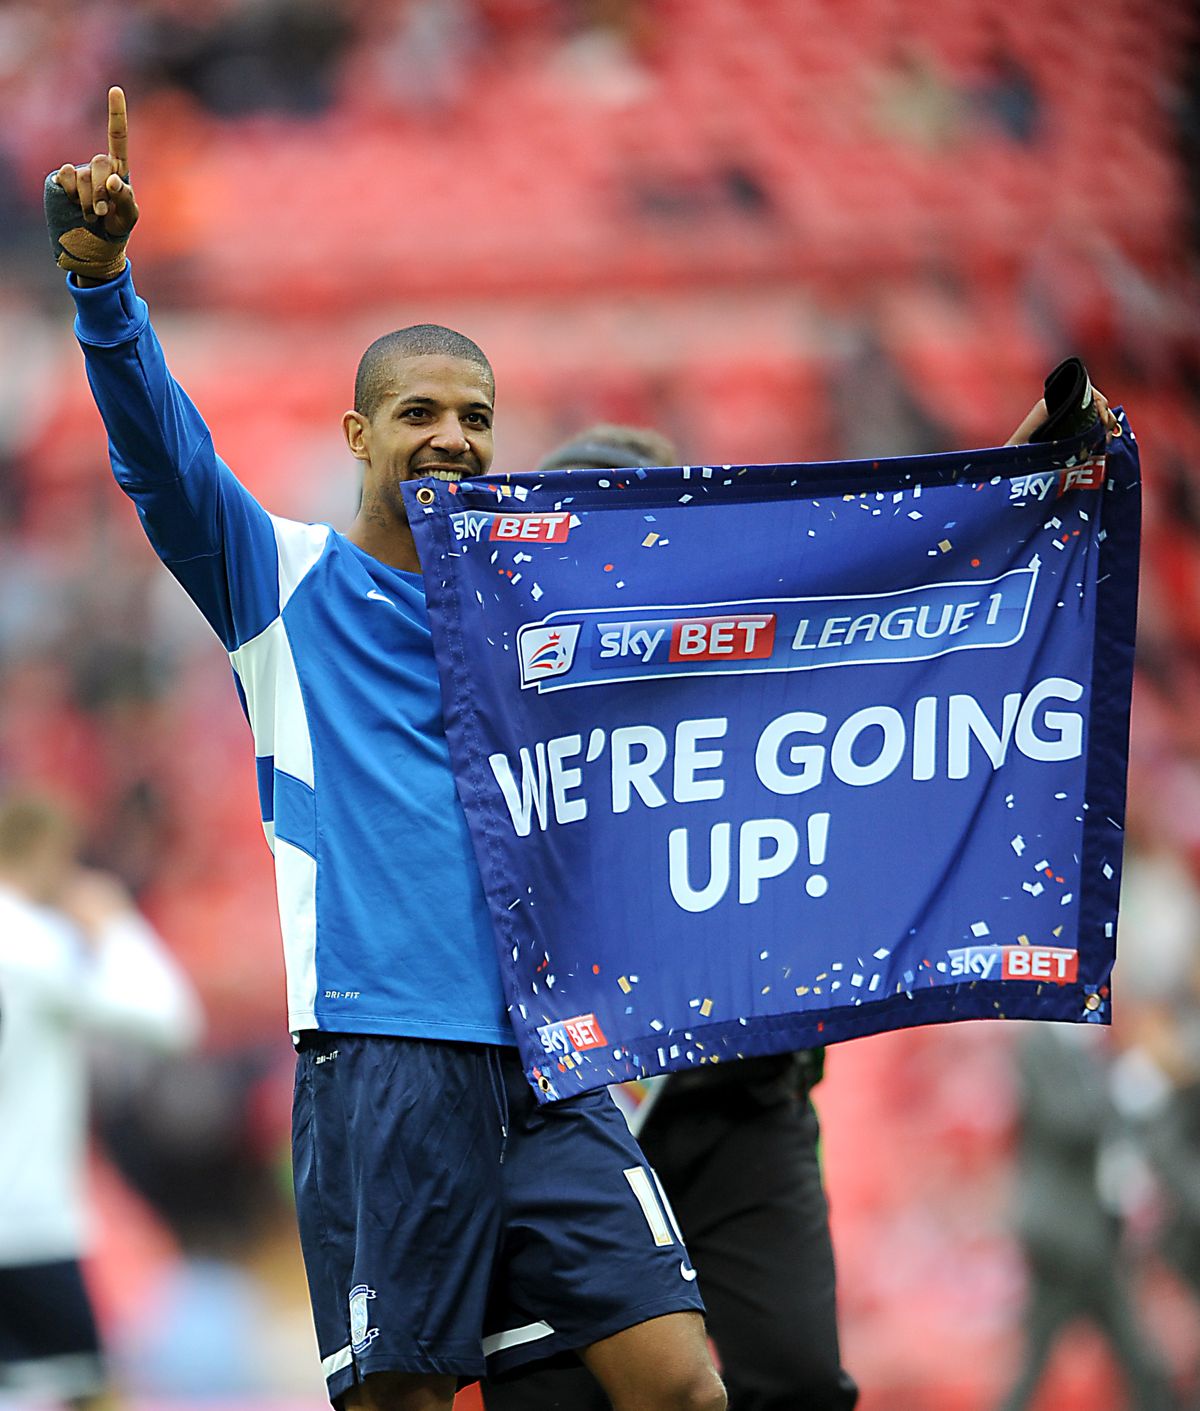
[0,793,202,1411]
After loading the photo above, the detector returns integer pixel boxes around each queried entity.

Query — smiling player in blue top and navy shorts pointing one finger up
[45,87,726,1411]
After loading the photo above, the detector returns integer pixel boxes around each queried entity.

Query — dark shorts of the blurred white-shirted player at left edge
[0,1259,106,1403]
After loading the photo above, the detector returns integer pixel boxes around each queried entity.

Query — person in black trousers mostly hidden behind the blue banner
[484,396,1111,1411]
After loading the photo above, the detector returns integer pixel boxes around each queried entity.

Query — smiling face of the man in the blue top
[343,353,496,522]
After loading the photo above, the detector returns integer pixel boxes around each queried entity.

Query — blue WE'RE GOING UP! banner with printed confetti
[404,418,1139,1101]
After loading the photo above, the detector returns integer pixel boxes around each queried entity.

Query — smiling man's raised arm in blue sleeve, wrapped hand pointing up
[45,87,280,650]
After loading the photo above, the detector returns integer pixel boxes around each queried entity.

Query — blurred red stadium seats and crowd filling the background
[0,0,1200,1411]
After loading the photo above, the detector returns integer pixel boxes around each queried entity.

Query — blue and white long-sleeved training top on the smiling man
[68,268,512,1043]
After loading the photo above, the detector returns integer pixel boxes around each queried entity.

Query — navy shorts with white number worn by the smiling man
[292,1031,703,1400]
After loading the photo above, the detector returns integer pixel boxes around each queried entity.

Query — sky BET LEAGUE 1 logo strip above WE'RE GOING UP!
[517,564,1038,693]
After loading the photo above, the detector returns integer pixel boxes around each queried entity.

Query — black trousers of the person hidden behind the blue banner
[483,1091,858,1411]
